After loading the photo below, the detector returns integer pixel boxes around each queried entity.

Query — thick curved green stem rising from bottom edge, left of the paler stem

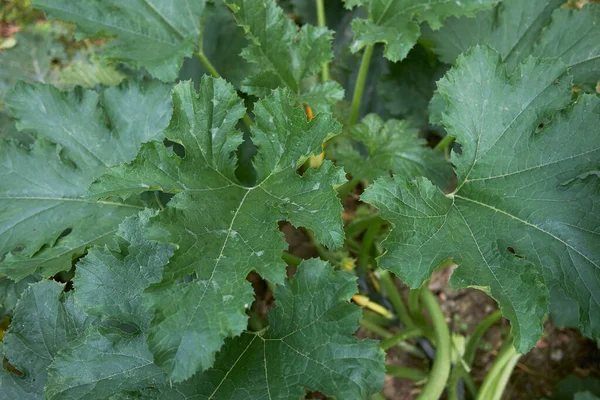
[418,285,451,400]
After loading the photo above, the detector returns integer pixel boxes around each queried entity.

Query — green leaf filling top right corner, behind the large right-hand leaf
[425,0,600,88]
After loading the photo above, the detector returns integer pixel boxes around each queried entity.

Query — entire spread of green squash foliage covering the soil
[0,0,600,399]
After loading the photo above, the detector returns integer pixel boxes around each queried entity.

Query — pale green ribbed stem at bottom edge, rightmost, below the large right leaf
[477,342,521,400]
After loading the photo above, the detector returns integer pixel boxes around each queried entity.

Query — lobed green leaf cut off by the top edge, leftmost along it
[32,0,205,81]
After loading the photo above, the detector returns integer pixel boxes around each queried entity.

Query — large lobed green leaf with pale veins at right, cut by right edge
[363,47,600,352]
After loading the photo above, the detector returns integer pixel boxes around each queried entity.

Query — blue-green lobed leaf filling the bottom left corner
[0,216,171,400]
